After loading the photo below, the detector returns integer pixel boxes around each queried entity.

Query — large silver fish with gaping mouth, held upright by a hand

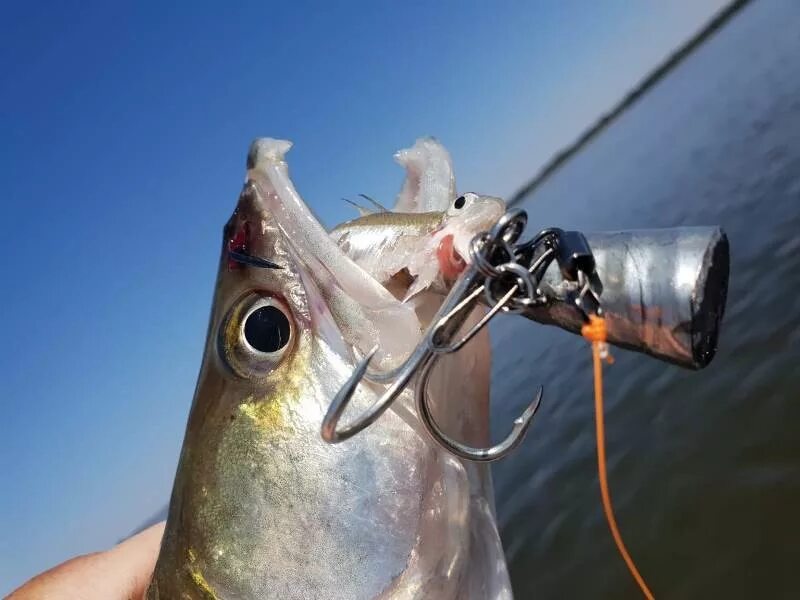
[146,138,511,600]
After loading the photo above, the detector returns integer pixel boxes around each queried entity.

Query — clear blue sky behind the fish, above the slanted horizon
[0,0,722,593]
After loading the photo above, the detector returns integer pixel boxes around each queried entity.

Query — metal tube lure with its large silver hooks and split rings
[321,209,729,462]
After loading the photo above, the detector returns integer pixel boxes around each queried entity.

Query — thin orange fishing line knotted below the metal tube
[581,315,654,600]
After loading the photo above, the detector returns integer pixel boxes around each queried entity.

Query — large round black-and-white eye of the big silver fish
[218,293,295,378]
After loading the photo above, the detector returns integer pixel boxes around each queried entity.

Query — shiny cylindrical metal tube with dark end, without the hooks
[524,227,730,369]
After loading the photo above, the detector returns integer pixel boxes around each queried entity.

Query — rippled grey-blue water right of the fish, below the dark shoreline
[493,0,800,598]
